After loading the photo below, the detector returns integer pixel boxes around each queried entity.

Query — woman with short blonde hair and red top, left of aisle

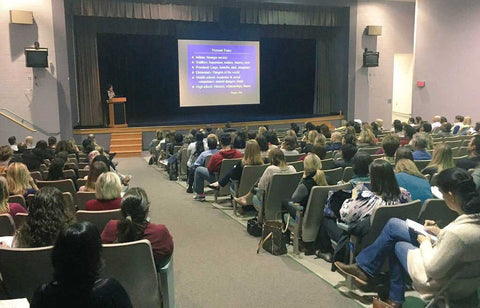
[85,172,122,211]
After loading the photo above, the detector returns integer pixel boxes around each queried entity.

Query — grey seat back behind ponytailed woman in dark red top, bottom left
[101,240,161,307]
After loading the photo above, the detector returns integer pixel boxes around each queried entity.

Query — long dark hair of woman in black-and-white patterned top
[370,159,400,202]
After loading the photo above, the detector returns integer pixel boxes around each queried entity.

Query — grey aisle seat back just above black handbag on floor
[258,172,303,220]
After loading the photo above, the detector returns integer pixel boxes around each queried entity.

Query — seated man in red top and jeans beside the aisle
[193,133,242,201]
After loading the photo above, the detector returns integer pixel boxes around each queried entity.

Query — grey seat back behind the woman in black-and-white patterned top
[361,200,422,247]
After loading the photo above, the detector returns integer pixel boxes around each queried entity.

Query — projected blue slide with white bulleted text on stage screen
[178,40,260,107]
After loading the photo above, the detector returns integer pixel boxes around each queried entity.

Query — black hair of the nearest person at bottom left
[52,221,102,294]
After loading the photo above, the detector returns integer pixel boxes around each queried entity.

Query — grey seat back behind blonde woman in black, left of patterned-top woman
[302,183,351,242]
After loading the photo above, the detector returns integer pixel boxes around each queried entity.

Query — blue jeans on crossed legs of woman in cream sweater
[356,218,419,303]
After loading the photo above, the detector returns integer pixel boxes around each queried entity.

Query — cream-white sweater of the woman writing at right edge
[407,214,480,298]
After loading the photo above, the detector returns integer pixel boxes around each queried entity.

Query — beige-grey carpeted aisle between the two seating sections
[118,158,359,307]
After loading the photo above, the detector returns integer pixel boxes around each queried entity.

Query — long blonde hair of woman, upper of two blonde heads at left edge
[7,163,38,196]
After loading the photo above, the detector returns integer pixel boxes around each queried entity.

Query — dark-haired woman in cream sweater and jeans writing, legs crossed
[335,168,480,307]
